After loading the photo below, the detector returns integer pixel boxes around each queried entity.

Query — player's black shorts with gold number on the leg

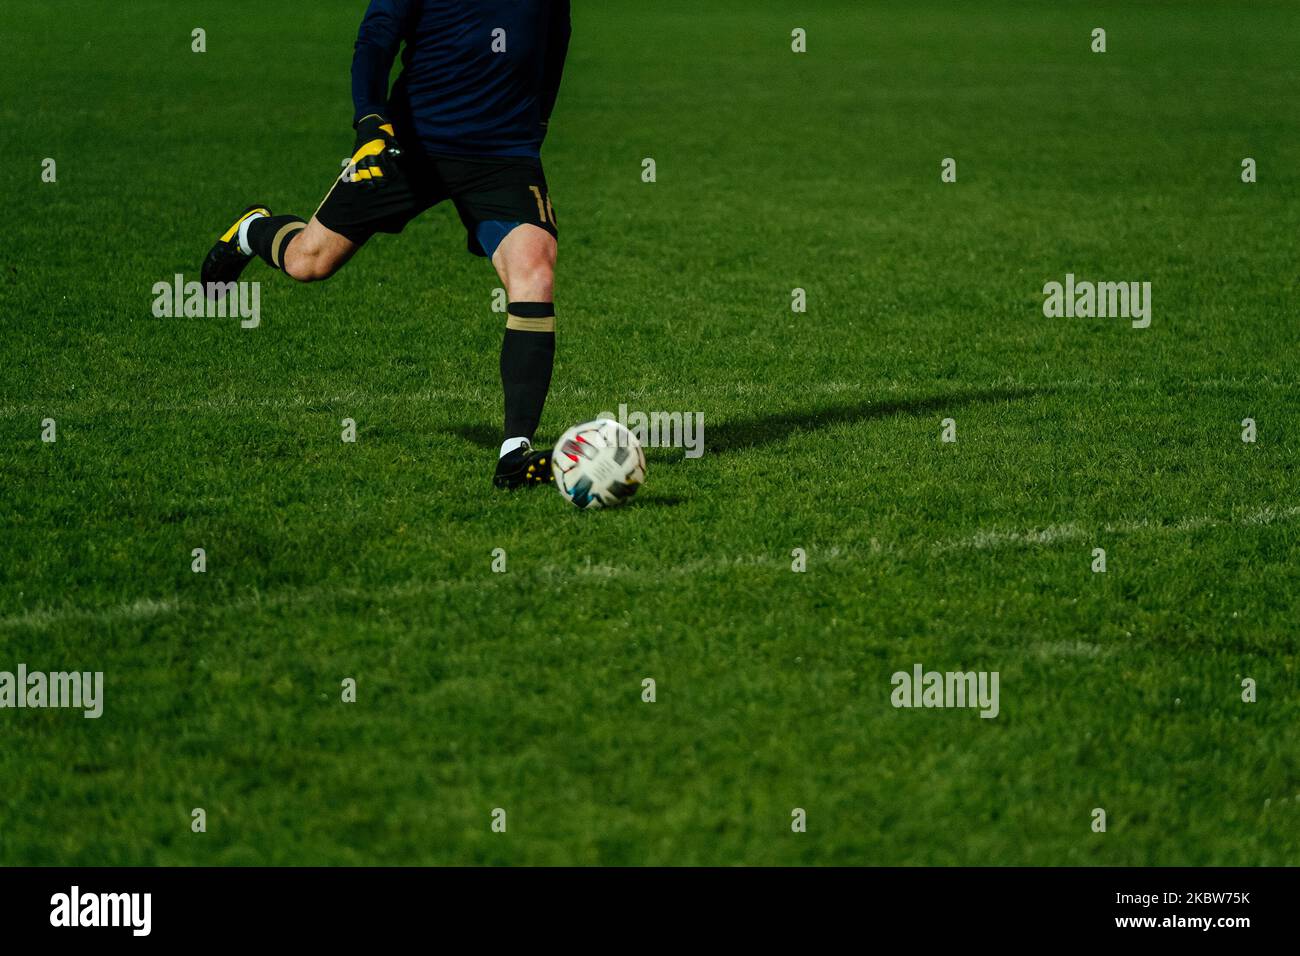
[316,150,559,256]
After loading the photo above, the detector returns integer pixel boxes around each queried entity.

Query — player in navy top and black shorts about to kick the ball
[202,0,569,488]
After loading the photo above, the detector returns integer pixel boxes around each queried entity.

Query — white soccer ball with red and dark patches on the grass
[551,419,646,509]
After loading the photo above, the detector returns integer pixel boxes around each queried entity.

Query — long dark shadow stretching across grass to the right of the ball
[705,388,1044,455]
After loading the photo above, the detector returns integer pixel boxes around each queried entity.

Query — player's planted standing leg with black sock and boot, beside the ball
[486,224,556,488]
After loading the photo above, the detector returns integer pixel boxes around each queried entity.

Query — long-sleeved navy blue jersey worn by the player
[352,0,569,156]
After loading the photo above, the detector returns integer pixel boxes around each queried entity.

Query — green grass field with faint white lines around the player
[0,0,1300,865]
